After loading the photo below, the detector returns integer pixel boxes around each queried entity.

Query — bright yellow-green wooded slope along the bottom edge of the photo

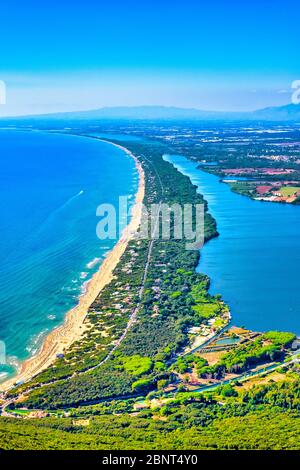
[0,411,299,450]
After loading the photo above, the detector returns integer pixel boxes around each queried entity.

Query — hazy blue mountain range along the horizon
[1,104,300,123]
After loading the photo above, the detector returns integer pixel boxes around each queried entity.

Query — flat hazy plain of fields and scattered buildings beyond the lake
[135,123,300,204]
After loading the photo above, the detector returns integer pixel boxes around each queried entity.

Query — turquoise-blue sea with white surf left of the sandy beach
[0,130,138,379]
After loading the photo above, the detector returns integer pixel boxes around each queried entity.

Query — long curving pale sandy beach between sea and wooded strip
[0,139,145,392]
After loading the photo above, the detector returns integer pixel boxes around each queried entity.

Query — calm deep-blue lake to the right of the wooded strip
[165,156,300,334]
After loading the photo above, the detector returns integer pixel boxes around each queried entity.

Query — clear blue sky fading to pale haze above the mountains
[0,0,300,116]
